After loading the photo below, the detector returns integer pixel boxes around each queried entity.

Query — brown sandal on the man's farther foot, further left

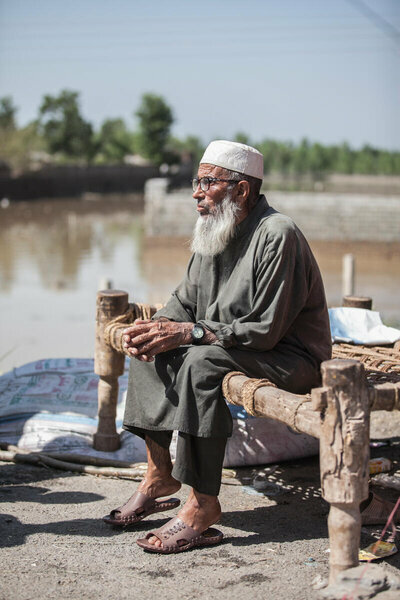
[103,492,181,527]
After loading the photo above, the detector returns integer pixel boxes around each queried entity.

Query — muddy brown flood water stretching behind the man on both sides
[0,198,400,373]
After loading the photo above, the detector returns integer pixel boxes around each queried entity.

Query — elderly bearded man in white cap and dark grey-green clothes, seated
[105,140,331,553]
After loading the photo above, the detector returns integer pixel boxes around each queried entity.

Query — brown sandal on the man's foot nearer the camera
[136,517,224,554]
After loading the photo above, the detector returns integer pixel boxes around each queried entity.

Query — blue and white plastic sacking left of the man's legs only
[0,358,146,462]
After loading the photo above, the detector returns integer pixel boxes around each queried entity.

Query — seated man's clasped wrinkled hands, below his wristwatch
[122,319,193,362]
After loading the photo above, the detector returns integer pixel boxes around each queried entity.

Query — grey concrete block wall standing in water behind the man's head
[145,179,400,242]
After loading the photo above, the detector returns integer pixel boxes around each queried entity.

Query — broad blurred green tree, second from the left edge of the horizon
[38,90,94,161]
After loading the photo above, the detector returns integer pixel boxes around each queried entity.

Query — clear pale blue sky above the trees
[0,0,400,150]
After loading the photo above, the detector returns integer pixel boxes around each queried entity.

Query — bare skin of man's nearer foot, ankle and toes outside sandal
[148,489,221,548]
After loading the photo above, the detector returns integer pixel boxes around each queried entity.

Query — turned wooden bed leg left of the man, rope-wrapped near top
[93,290,128,452]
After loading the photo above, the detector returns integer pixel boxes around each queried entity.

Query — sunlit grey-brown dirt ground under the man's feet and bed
[0,413,400,600]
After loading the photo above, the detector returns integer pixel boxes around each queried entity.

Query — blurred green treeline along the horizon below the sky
[0,90,400,179]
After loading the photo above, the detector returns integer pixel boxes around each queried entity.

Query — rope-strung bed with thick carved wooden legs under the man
[93,290,400,582]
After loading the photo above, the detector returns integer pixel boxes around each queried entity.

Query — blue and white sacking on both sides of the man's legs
[0,359,318,467]
